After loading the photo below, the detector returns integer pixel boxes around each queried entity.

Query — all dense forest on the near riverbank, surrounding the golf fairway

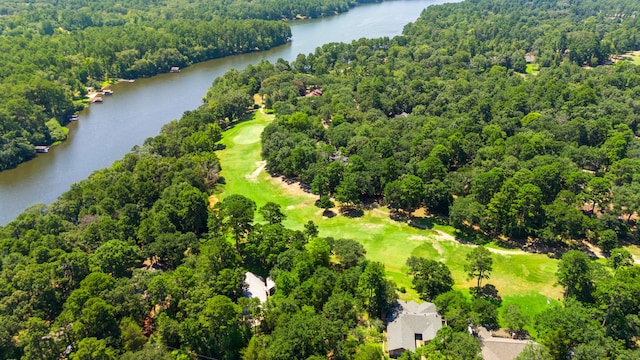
[0,0,640,360]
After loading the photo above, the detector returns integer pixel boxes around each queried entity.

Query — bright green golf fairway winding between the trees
[216,112,562,320]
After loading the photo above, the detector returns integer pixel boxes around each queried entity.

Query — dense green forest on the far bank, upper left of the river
[0,0,380,171]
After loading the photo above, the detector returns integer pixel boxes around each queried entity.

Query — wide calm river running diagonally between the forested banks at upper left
[0,0,454,225]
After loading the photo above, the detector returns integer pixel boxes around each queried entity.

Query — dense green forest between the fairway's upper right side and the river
[260,1,640,251]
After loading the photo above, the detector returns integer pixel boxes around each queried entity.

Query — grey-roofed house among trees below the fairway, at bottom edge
[387,300,442,358]
